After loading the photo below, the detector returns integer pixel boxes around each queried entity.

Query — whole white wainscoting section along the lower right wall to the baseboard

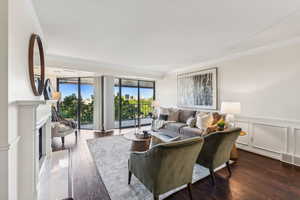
[235,116,300,166]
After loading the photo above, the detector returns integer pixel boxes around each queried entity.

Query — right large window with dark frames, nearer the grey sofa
[114,78,155,128]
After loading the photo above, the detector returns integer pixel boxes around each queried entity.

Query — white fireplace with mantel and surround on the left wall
[16,100,56,200]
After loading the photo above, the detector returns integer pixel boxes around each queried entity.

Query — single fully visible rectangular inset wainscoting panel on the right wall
[253,123,288,154]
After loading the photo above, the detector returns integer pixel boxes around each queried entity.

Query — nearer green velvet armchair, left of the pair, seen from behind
[128,137,203,200]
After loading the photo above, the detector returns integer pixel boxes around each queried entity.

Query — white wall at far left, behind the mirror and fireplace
[0,0,42,200]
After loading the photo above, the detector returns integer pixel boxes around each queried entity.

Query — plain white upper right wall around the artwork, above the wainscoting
[157,44,300,120]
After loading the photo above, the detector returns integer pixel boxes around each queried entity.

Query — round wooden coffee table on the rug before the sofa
[124,132,151,152]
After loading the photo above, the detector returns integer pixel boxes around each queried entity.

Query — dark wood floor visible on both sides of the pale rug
[53,131,300,200]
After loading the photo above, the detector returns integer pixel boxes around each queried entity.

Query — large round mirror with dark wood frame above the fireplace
[28,34,45,96]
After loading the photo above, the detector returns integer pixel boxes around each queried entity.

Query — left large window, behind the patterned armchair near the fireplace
[57,78,94,129]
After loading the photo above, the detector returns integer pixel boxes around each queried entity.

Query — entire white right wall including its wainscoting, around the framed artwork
[156,44,300,165]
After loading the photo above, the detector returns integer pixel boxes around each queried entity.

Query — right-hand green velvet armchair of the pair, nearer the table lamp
[197,128,241,185]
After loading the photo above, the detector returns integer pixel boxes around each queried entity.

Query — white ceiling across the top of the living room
[35,0,300,78]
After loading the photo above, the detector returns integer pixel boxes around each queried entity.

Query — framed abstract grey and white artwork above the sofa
[177,68,217,109]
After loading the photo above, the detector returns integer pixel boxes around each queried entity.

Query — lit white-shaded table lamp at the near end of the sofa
[221,102,241,128]
